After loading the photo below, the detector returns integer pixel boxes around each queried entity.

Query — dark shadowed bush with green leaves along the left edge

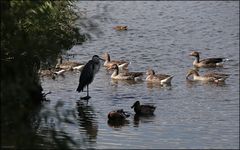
[0,0,85,148]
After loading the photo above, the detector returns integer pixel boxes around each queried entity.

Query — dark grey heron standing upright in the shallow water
[77,55,103,100]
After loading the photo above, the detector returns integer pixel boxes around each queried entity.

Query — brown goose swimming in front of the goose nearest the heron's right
[110,64,143,81]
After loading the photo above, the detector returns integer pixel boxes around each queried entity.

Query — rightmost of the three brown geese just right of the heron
[146,69,173,85]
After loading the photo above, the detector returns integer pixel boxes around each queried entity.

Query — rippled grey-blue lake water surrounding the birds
[38,1,239,149]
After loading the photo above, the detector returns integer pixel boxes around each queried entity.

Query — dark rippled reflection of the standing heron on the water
[77,101,98,142]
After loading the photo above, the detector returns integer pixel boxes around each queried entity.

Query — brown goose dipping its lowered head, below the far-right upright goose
[186,69,229,83]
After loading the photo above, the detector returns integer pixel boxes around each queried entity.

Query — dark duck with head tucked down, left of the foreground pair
[108,109,130,121]
